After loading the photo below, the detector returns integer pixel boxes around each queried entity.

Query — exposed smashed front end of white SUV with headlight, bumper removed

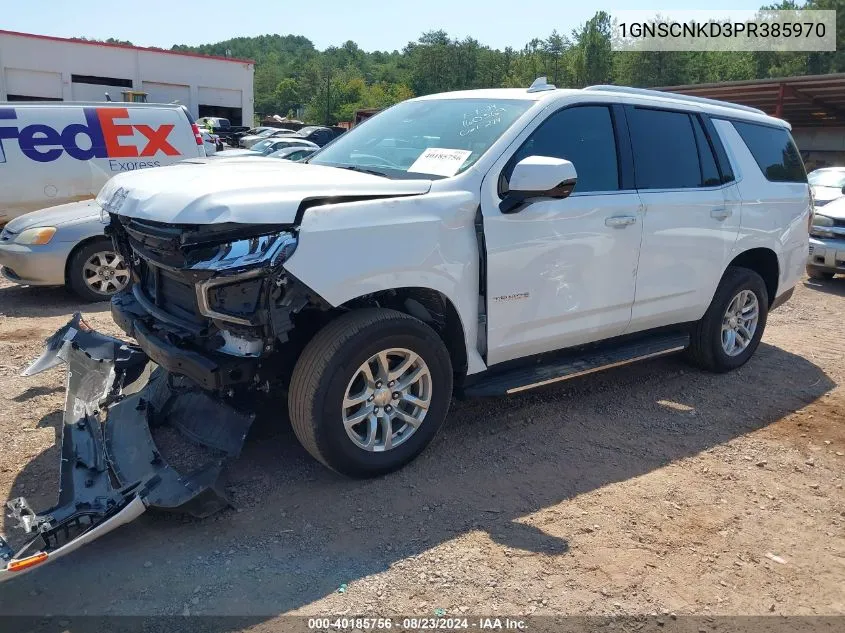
[109,215,321,393]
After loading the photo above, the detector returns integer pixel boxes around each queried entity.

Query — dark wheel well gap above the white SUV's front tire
[339,287,468,377]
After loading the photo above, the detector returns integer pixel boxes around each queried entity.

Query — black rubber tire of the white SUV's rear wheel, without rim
[687,267,769,373]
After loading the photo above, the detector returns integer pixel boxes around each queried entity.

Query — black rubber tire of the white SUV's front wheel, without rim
[288,308,452,477]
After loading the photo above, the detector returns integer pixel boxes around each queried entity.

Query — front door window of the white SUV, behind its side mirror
[506,106,619,193]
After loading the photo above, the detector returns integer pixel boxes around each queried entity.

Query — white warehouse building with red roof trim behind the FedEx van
[0,30,255,125]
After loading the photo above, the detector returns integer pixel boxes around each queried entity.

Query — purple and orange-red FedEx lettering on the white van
[0,108,179,163]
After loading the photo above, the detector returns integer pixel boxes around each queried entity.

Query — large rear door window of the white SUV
[627,107,705,189]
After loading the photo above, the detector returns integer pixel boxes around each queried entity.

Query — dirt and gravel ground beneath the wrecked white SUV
[0,279,845,629]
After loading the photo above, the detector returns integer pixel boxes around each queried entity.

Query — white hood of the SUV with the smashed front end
[97,159,431,224]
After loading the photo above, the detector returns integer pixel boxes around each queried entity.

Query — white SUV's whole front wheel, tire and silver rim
[288,308,452,477]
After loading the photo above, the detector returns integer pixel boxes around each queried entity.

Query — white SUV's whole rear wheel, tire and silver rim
[688,268,769,372]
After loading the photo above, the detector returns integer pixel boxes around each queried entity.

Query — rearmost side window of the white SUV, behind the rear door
[733,121,807,182]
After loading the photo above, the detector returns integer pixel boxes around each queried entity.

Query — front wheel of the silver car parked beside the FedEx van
[68,238,129,301]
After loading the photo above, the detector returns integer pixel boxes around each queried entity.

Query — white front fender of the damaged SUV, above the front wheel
[285,191,486,374]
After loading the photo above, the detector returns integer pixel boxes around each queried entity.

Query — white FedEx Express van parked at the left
[0,101,205,226]
